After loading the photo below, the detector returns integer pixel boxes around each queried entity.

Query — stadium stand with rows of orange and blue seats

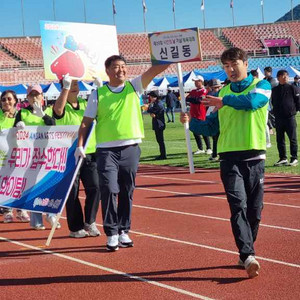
[0,21,300,85]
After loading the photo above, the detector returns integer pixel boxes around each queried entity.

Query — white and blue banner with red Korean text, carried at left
[0,125,79,214]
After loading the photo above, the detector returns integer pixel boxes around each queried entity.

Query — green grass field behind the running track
[140,113,300,175]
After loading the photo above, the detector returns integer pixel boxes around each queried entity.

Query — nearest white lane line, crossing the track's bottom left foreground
[0,237,213,300]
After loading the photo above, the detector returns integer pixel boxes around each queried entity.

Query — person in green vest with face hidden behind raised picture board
[53,75,102,238]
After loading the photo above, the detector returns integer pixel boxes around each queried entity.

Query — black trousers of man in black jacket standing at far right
[276,116,298,159]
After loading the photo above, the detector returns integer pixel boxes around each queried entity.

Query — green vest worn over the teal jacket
[218,78,268,153]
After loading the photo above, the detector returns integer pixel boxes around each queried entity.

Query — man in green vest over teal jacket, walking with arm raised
[181,48,271,278]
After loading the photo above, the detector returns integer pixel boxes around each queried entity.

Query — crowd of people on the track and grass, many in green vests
[0,48,300,278]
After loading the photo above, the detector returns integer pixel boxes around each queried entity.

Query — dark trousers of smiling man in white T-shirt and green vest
[96,144,141,236]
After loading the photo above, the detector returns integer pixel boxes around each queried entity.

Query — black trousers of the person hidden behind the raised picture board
[66,153,100,231]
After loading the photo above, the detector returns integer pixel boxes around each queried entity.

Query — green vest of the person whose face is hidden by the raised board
[56,98,96,154]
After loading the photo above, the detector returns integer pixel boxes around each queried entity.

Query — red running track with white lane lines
[0,166,300,300]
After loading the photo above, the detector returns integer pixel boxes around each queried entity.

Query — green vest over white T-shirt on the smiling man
[96,81,144,144]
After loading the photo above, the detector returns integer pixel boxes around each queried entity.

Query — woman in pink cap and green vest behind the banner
[14,84,60,230]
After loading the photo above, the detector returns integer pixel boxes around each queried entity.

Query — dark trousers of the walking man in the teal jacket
[220,160,265,261]
